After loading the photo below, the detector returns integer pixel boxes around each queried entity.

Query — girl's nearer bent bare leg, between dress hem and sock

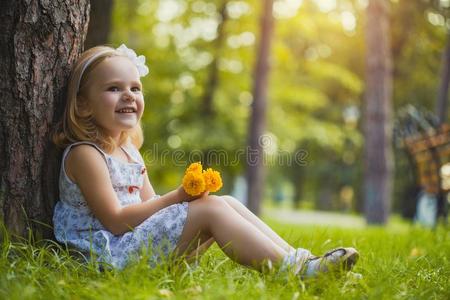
[177,196,287,269]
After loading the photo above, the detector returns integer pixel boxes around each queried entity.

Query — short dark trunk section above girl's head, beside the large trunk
[84,0,114,49]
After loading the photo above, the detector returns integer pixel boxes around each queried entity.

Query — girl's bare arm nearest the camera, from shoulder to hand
[66,145,186,235]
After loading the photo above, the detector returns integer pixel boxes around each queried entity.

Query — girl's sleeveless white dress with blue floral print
[53,142,188,269]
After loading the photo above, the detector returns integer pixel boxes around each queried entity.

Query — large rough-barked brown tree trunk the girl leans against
[0,0,89,237]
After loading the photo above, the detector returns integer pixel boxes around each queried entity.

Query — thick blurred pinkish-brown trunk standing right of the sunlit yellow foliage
[364,0,393,224]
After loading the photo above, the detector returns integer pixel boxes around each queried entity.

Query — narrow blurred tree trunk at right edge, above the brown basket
[436,32,450,124]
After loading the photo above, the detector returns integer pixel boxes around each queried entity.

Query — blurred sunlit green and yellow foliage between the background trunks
[109,0,448,218]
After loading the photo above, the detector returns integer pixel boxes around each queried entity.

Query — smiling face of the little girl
[81,56,144,138]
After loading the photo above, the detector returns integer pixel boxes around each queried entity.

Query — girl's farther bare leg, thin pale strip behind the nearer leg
[221,195,295,252]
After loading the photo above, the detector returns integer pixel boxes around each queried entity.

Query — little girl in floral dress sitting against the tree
[53,45,358,277]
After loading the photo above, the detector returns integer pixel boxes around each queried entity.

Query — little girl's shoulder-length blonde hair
[52,46,144,152]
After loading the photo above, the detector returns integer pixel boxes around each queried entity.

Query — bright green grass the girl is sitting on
[0,220,450,299]
